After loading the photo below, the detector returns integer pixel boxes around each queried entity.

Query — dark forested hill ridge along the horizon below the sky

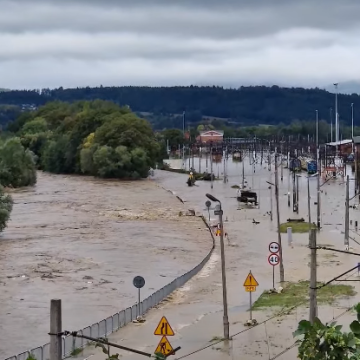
[0,86,360,127]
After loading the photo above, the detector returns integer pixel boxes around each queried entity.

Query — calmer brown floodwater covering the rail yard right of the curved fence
[83,154,360,360]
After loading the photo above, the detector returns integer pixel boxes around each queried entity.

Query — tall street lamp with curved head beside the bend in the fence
[206,194,229,340]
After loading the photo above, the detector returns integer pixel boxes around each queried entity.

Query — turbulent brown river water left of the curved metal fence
[0,173,212,358]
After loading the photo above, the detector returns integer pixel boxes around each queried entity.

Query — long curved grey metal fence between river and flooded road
[5,217,215,360]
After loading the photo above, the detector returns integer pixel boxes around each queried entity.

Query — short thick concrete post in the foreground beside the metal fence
[50,299,62,360]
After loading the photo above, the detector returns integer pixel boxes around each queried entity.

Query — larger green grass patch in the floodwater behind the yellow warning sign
[252,281,356,310]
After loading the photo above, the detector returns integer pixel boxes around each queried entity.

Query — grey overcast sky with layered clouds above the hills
[0,0,360,88]
